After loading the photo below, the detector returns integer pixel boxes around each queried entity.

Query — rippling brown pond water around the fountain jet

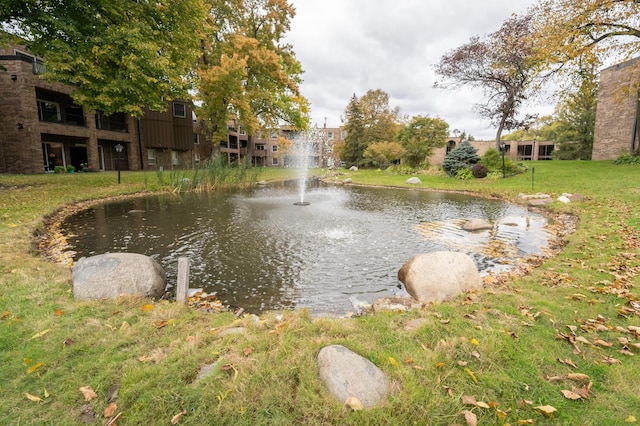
[63,184,548,315]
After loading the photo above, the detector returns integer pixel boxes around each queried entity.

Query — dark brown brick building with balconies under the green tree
[0,40,212,173]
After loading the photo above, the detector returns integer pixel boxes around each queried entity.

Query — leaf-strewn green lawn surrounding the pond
[0,162,640,425]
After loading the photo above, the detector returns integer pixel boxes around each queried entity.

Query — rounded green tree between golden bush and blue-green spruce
[397,115,449,167]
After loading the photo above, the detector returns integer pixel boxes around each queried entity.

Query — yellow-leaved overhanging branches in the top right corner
[531,0,640,71]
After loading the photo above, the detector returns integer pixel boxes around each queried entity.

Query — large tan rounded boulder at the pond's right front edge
[398,251,482,303]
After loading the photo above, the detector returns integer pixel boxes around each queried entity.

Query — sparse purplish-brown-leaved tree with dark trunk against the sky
[435,16,538,147]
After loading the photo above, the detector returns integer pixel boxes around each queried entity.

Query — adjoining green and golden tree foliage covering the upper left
[0,0,308,143]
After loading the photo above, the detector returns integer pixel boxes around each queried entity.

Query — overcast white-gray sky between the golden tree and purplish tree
[286,0,553,139]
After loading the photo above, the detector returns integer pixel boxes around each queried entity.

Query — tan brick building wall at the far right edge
[591,58,640,160]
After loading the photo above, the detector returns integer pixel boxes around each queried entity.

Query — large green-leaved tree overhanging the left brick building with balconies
[0,0,206,117]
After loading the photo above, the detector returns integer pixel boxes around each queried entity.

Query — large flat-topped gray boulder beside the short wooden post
[72,253,167,300]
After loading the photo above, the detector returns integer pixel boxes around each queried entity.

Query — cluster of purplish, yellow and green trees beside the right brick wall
[435,0,640,159]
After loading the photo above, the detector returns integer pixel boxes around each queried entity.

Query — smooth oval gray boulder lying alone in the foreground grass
[318,345,389,408]
